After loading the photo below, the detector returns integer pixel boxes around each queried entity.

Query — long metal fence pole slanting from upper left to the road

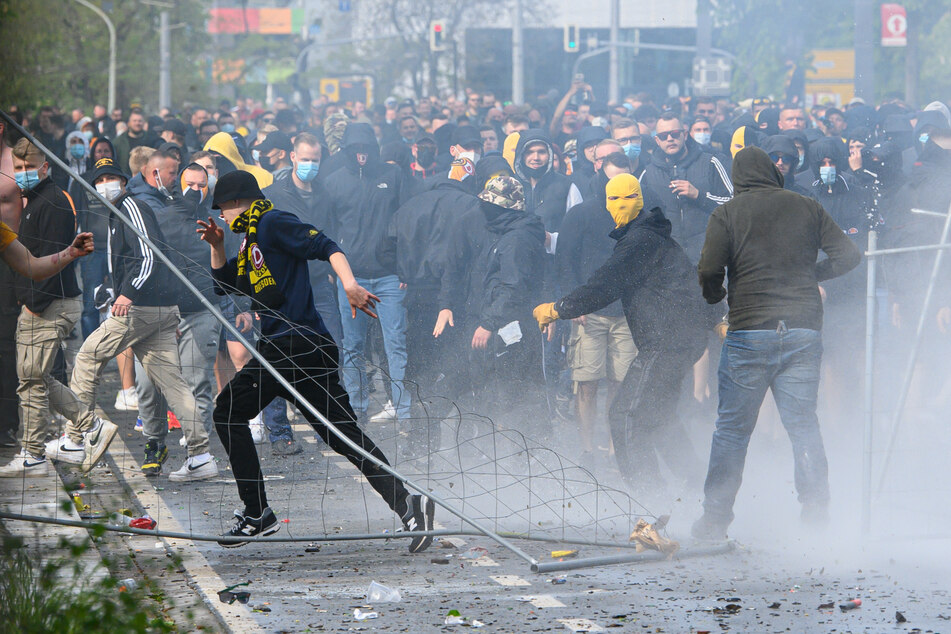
[0,110,538,565]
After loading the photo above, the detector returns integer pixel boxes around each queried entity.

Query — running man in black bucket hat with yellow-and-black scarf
[198,169,436,553]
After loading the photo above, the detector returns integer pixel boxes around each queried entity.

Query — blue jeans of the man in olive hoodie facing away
[703,322,829,523]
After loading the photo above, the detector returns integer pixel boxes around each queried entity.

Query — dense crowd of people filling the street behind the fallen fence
[0,74,951,550]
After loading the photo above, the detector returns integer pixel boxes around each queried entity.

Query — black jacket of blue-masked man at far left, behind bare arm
[16,178,80,313]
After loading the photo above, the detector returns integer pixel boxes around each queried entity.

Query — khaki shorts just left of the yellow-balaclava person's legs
[568,314,637,382]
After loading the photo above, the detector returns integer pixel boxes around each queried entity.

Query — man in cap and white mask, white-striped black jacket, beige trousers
[67,159,218,482]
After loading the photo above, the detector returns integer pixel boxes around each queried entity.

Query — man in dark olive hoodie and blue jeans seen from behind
[692,147,861,539]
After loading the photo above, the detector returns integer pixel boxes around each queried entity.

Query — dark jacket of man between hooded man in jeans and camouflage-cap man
[383,179,479,288]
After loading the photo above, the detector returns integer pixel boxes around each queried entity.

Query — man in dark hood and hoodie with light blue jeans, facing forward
[324,123,411,419]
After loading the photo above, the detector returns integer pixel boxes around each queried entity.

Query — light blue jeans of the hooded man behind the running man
[337,275,411,419]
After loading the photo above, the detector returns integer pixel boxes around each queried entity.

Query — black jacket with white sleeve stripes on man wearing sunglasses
[638,138,733,262]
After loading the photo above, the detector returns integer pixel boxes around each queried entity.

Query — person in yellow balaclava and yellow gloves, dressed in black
[534,174,706,494]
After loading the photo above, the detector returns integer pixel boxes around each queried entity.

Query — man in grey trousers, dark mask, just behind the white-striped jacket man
[130,163,227,477]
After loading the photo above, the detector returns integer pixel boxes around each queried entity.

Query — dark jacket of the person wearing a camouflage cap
[478,201,545,333]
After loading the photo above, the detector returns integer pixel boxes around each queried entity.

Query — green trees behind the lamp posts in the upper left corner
[0,0,209,110]
